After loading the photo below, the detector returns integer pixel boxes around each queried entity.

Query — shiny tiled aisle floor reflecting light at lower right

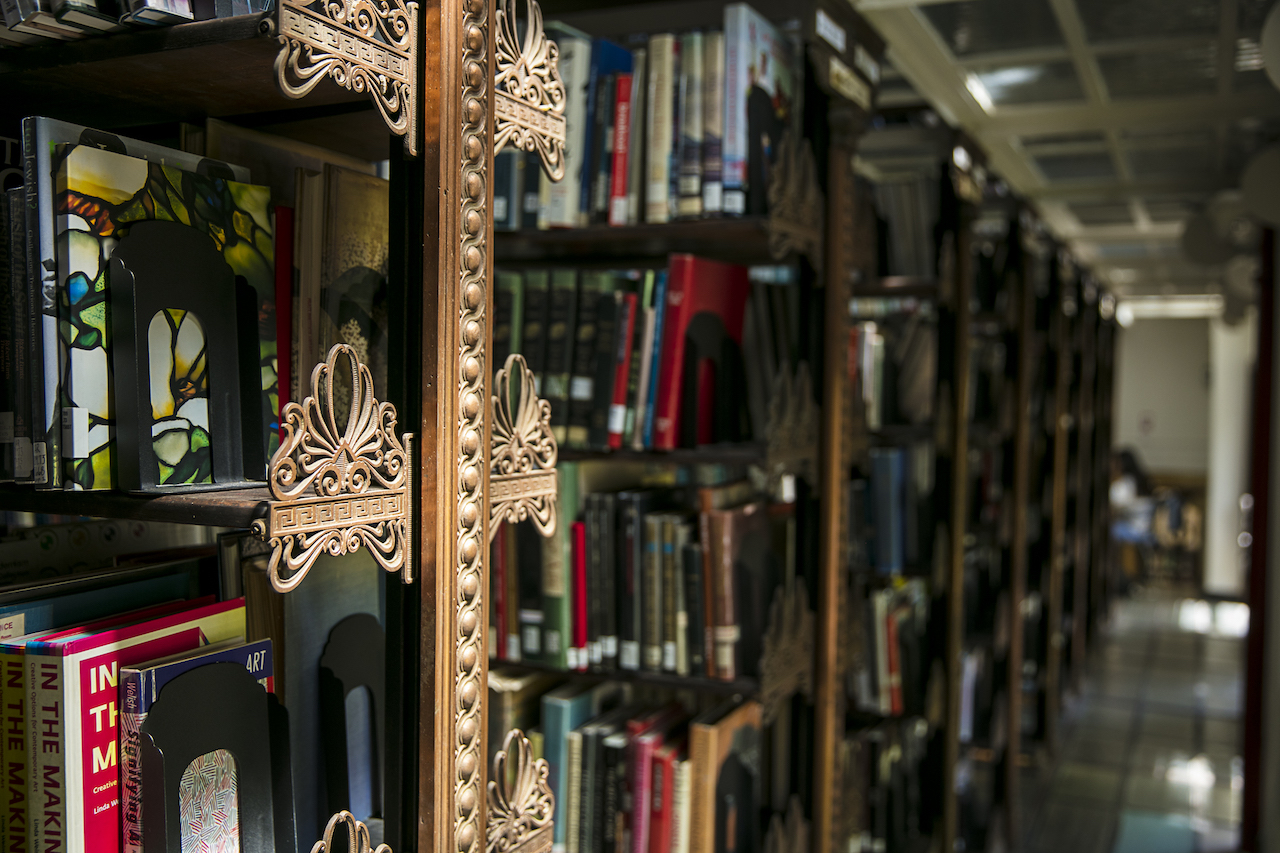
[1020,592,1248,853]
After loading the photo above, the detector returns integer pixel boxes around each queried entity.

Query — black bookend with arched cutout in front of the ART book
[140,663,297,853]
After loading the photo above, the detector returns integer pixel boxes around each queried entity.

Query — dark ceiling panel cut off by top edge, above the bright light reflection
[920,0,1064,56]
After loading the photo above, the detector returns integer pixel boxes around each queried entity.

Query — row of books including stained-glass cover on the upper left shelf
[0,117,389,489]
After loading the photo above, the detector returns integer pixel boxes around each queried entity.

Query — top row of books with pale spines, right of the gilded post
[494,3,803,229]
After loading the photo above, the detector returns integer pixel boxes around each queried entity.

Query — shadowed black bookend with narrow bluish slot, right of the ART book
[320,613,387,820]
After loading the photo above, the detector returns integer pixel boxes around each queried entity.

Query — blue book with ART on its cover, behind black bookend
[119,638,274,853]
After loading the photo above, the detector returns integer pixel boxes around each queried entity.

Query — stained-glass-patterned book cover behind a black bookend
[55,145,279,489]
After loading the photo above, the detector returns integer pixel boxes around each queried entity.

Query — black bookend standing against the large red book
[677,311,750,447]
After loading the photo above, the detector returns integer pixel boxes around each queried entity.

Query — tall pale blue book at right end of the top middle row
[723,3,796,215]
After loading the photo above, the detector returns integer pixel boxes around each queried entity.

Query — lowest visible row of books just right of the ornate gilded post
[489,670,786,853]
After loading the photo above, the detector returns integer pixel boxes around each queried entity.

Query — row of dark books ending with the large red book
[493,255,799,450]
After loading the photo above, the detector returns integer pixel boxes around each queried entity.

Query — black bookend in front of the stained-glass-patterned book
[108,216,265,491]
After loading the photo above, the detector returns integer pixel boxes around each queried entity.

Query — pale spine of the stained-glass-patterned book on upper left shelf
[22,117,52,489]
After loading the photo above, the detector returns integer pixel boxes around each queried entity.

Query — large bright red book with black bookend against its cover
[653,255,750,450]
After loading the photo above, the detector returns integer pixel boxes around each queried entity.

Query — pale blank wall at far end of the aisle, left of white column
[1114,319,1210,475]
